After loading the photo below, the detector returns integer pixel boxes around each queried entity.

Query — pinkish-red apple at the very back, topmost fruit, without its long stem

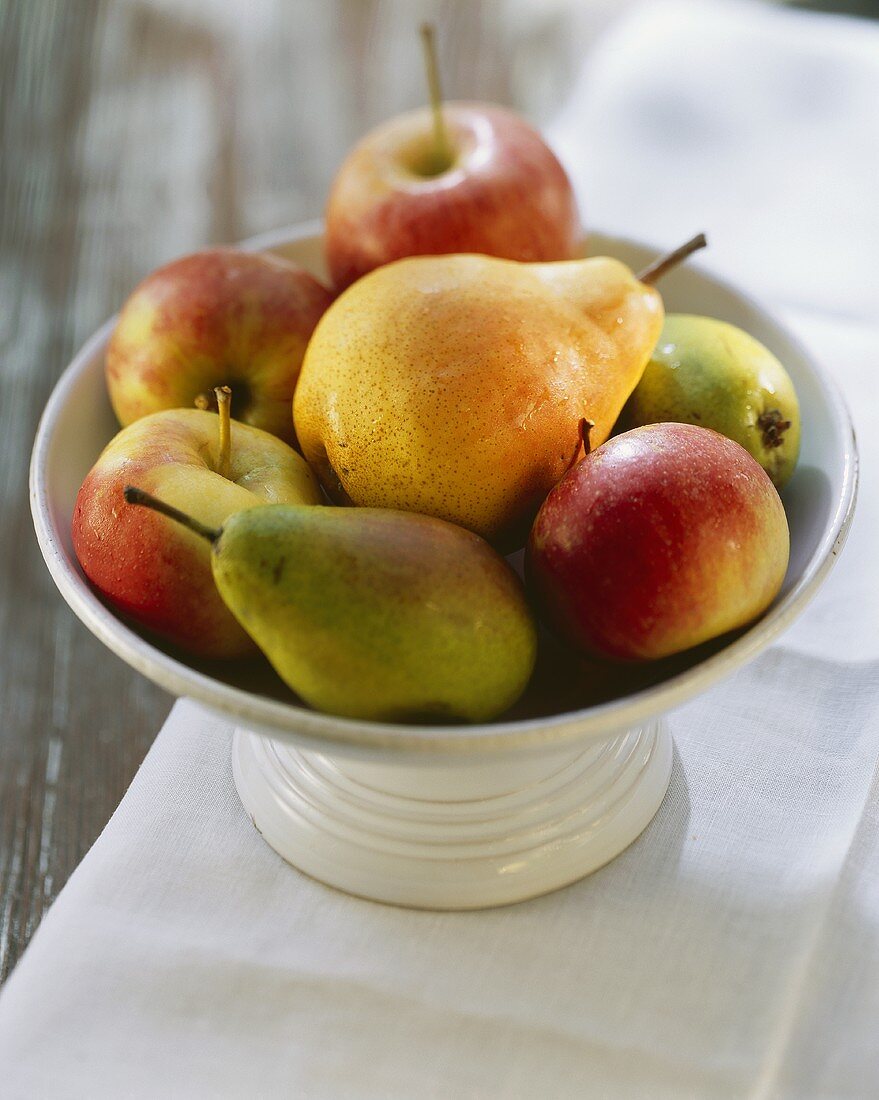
[326,103,582,289]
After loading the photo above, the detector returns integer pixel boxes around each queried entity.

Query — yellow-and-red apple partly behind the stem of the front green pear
[73,409,322,658]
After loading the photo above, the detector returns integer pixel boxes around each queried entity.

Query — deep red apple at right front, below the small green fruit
[526,424,790,660]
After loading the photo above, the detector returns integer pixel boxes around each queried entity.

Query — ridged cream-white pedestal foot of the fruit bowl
[232,722,672,910]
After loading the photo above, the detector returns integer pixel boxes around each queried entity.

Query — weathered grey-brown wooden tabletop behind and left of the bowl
[0,0,609,980]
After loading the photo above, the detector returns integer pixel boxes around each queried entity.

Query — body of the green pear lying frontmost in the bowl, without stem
[212,505,537,722]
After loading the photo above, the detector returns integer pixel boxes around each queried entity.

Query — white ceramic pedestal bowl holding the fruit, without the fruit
[31,226,857,908]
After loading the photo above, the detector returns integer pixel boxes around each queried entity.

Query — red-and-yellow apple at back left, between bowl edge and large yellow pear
[107,249,332,442]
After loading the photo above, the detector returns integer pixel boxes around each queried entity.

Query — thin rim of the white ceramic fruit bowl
[30,221,858,756]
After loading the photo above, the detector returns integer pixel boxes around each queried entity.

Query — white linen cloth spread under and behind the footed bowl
[0,3,879,1098]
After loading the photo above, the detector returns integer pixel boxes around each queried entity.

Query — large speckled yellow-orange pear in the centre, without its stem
[294,255,662,548]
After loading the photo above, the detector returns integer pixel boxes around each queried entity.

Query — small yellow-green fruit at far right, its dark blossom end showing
[620,314,800,488]
